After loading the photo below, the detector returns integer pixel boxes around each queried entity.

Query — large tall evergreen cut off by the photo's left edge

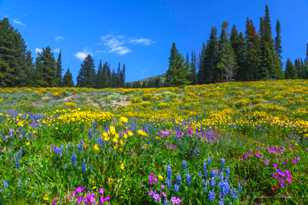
[0,18,32,86]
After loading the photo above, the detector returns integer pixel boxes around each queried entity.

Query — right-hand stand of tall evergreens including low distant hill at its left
[129,6,308,87]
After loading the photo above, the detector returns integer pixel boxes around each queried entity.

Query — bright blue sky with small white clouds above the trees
[0,0,308,81]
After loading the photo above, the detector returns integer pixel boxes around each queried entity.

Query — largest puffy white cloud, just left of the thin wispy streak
[101,34,131,55]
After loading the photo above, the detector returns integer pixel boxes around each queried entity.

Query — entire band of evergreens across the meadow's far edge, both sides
[0,6,308,88]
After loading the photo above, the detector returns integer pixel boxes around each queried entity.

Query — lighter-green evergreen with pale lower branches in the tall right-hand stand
[216,22,237,81]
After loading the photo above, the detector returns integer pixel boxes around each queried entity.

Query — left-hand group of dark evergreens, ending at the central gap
[0,18,125,88]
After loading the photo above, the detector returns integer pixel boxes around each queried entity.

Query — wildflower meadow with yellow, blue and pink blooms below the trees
[0,80,308,204]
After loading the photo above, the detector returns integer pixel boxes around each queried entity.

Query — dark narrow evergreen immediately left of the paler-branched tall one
[199,27,218,83]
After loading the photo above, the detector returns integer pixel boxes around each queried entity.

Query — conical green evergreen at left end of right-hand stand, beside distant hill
[166,43,191,86]
